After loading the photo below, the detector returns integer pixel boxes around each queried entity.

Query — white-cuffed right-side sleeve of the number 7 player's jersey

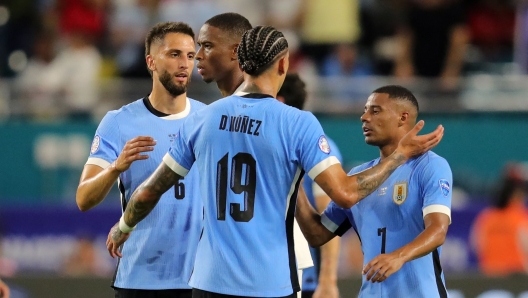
[418,156,453,220]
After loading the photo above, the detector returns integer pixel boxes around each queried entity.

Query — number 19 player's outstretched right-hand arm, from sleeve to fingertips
[314,120,444,209]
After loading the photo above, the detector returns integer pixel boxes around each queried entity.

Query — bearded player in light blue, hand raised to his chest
[77,22,205,298]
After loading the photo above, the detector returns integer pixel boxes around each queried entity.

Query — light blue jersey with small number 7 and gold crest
[321,152,453,298]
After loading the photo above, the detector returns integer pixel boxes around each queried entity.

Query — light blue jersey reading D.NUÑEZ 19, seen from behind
[163,93,339,297]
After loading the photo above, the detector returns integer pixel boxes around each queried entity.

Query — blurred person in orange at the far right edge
[472,167,528,276]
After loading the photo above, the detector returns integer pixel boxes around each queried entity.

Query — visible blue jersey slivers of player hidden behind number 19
[302,138,343,292]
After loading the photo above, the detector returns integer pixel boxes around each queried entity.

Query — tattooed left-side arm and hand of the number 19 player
[106,162,182,257]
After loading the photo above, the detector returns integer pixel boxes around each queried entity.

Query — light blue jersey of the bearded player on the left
[87,99,205,290]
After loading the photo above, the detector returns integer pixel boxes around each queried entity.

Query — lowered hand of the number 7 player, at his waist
[362,253,405,283]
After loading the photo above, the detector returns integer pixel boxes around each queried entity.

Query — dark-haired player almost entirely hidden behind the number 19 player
[277,74,343,298]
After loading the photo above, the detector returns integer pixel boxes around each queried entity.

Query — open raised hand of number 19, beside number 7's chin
[396,120,444,158]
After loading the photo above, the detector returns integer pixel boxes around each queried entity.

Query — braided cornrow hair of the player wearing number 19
[237,26,288,76]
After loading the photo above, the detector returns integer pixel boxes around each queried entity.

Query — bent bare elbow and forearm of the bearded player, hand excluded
[75,164,121,211]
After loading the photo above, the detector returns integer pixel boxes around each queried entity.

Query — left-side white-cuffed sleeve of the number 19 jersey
[163,116,196,177]
